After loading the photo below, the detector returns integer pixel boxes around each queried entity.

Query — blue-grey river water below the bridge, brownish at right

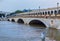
[0,21,60,41]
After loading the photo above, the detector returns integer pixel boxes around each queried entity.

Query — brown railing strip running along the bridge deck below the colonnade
[8,13,60,18]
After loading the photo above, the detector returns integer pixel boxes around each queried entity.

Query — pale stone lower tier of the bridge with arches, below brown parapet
[7,17,60,28]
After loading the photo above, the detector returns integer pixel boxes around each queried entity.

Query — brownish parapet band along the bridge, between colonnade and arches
[7,14,60,19]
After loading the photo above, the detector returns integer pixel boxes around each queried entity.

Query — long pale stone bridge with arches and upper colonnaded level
[7,7,60,28]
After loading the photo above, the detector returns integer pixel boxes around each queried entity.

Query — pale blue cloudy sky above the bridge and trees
[0,0,60,12]
